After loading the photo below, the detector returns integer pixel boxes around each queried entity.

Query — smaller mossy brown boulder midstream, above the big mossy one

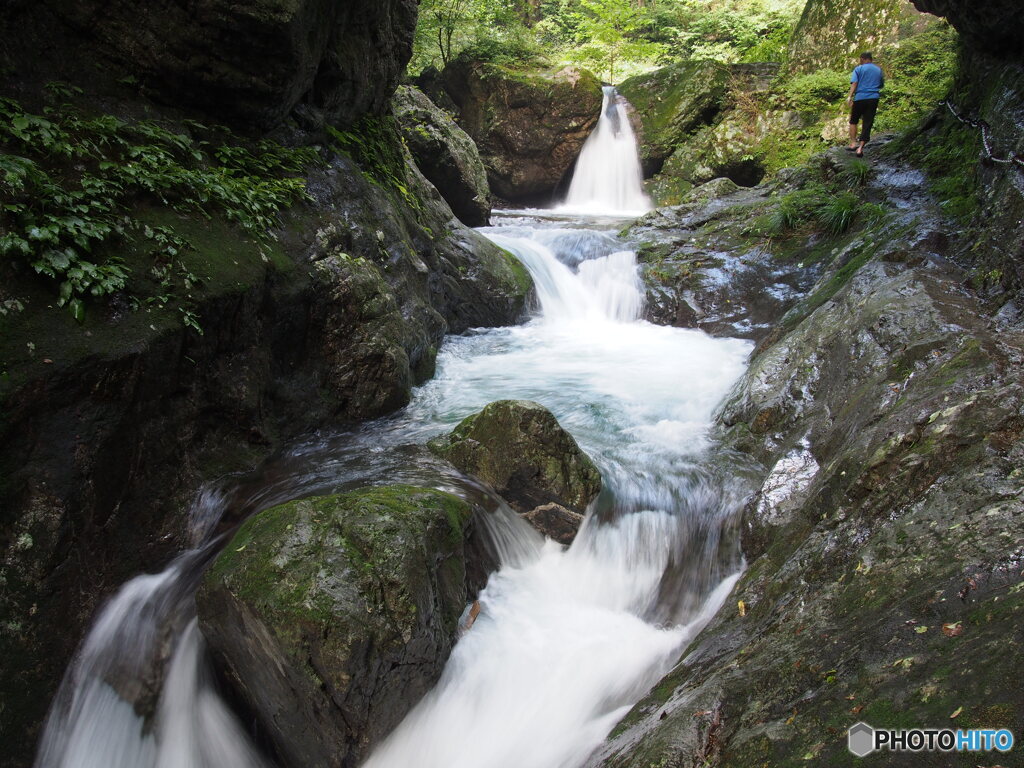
[429,400,601,543]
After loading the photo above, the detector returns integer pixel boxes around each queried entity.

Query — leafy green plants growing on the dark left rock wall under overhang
[0,94,315,327]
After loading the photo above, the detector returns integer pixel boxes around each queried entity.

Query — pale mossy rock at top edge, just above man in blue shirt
[786,0,927,73]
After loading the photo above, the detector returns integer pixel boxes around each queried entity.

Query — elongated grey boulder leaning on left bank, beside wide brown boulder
[391,85,490,226]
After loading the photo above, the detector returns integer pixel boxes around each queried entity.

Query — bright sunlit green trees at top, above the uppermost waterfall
[410,0,800,81]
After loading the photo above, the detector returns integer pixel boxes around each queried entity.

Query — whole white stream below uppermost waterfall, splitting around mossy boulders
[36,92,750,768]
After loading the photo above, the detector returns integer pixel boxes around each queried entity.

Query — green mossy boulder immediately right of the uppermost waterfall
[618,61,729,176]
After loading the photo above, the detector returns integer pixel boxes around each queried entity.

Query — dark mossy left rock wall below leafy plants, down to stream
[0,137,530,765]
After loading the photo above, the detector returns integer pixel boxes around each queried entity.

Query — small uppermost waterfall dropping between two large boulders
[560,85,651,216]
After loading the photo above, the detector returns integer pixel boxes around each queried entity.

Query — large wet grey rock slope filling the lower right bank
[590,138,1024,768]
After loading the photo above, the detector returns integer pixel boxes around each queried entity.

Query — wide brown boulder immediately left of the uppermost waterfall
[428,56,602,202]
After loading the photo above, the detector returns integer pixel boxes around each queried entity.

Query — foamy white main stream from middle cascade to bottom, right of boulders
[366,223,750,768]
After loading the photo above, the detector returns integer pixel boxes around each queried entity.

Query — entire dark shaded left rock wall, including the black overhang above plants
[0,0,531,768]
